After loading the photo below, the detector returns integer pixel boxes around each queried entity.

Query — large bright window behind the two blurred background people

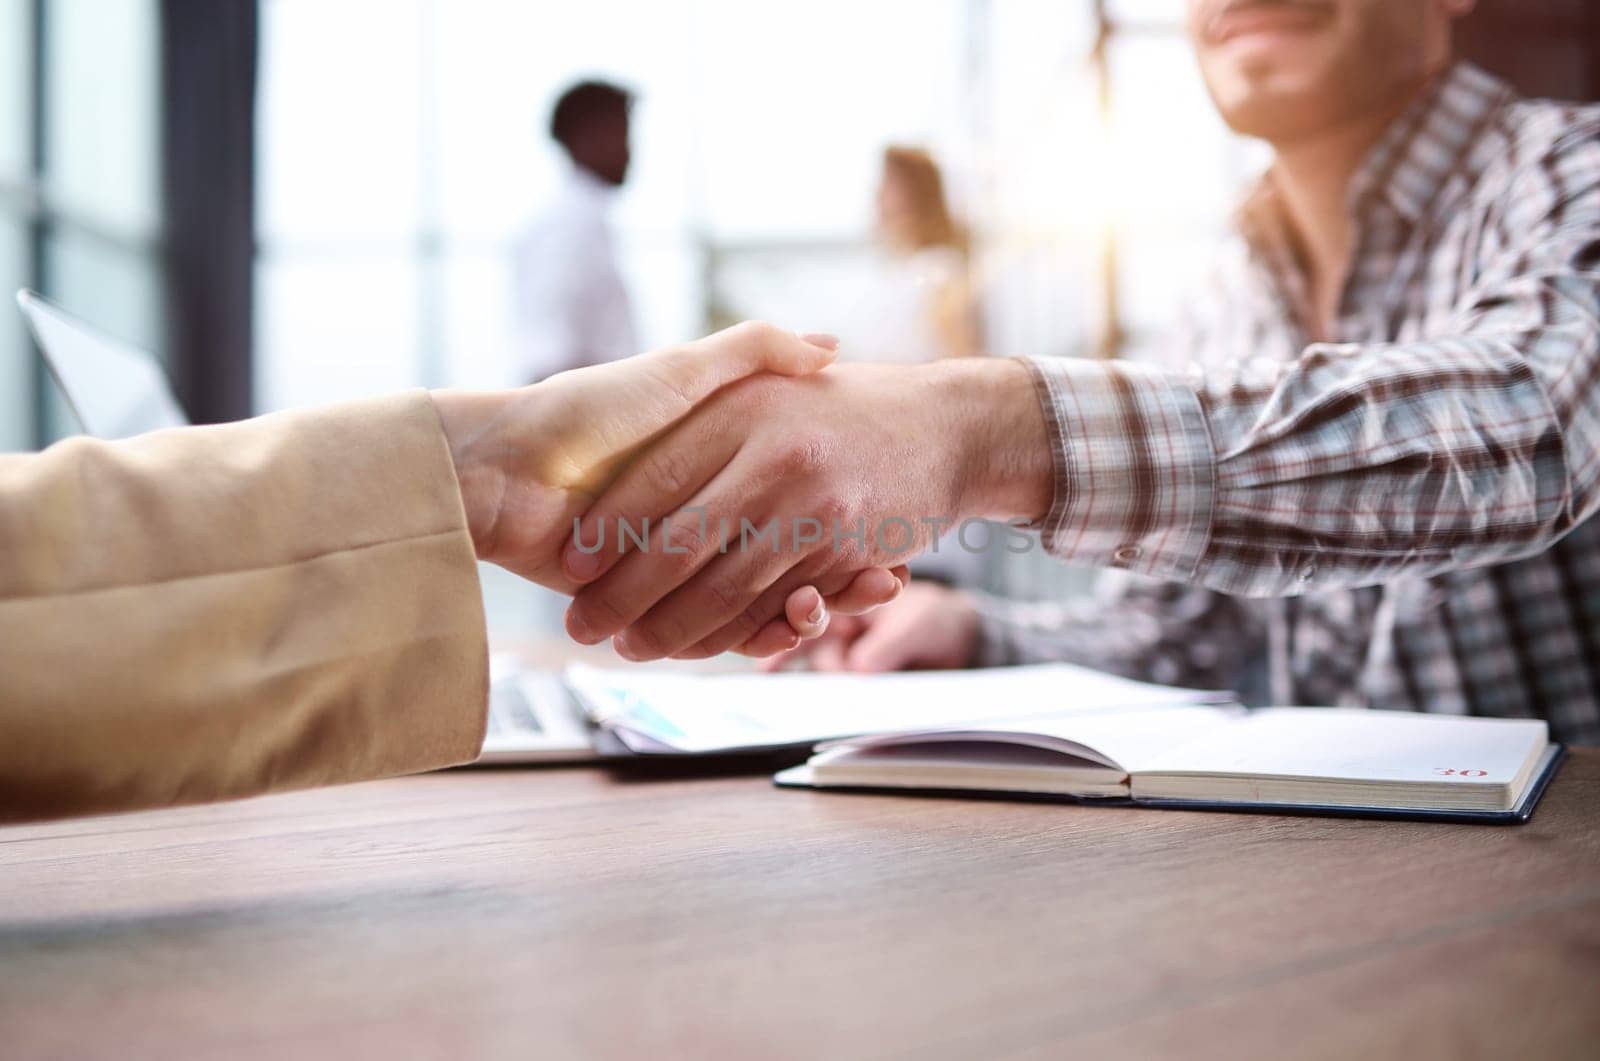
[256,0,1253,624]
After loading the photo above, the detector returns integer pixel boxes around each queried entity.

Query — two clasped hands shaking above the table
[432,323,1051,659]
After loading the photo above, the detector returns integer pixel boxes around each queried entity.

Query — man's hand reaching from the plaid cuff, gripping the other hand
[563,358,1051,659]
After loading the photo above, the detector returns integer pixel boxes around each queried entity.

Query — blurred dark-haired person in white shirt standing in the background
[514,82,640,382]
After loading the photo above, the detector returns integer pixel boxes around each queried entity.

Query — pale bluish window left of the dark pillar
[0,0,163,450]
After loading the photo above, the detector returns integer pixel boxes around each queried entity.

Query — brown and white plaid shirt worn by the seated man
[979,66,1600,743]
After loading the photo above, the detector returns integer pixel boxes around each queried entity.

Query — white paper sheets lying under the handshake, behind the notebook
[566,664,1227,752]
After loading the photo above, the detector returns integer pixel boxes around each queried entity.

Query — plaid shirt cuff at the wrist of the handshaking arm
[1022,358,1216,581]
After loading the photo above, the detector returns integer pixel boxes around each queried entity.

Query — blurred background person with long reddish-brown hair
[846,146,981,365]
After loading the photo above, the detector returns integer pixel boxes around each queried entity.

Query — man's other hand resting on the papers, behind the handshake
[762,583,978,674]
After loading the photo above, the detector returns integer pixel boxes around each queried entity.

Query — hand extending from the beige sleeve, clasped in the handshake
[432,323,899,655]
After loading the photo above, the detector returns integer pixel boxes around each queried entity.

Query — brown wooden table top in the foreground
[0,751,1600,1058]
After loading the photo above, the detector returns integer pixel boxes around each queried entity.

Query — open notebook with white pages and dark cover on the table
[776,706,1562,821]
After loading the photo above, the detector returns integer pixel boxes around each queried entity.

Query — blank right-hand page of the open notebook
[1133,707,1549,784]
